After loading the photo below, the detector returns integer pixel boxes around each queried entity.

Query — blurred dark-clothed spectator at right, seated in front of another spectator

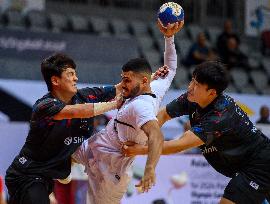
[220,37,249,69]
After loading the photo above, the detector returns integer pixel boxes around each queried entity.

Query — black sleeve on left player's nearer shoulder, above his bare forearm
[33,98,66,120]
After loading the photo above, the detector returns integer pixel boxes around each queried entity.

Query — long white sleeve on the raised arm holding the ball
[151,36,177,103]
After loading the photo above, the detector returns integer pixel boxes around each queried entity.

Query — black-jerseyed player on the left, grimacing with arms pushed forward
[5,54,122,204]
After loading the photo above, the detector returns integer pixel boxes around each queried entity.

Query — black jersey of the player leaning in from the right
[166,93,270,187]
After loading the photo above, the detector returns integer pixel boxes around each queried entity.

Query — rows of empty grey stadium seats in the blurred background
[0,7,270,94]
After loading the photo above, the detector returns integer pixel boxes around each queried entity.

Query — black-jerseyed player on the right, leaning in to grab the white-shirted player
[123,62,270,204]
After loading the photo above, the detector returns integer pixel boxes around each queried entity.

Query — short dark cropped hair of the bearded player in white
[122,58,152,75]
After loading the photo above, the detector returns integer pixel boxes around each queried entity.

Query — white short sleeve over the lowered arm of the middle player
[131,100,157,128]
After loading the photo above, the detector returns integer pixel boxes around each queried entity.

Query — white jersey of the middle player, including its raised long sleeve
[73,37,177,203]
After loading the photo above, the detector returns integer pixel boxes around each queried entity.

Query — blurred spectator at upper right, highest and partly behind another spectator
[217,20,240,56]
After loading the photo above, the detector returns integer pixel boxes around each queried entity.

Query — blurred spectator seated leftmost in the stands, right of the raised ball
[183,33,216,66]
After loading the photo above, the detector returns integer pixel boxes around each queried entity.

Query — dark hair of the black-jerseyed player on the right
[192,61,229,95]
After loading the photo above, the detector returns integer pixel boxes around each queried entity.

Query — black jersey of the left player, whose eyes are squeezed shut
[7,86,116,179]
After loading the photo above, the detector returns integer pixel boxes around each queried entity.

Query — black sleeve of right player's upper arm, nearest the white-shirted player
[166,93,190,118]
